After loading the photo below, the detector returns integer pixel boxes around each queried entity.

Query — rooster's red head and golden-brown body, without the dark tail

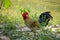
[22,12,40,32]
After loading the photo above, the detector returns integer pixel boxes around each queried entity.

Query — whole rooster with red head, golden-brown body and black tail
[22,11,53,31]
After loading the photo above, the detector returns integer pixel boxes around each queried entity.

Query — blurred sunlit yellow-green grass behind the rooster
[0,0,60,25]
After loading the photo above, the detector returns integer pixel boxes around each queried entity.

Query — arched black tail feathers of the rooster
[39,11,53,26]
